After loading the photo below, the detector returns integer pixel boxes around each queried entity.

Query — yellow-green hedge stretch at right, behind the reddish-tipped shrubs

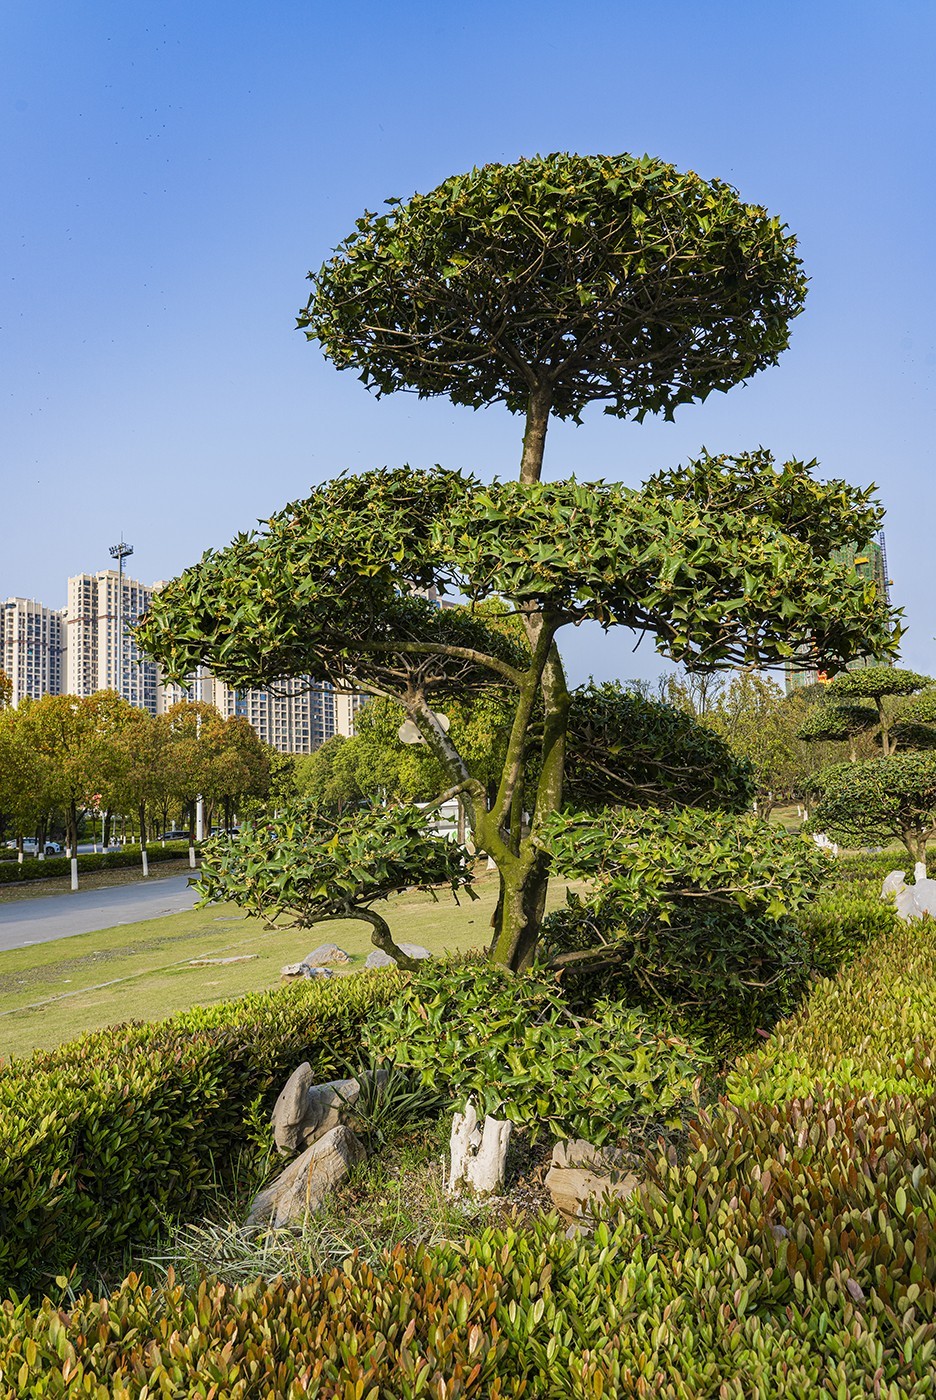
[728,920,936,1105]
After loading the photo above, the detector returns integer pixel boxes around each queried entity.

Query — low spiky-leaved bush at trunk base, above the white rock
[367,963,708,1142]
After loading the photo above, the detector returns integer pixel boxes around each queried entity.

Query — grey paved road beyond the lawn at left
[0,875,197,952]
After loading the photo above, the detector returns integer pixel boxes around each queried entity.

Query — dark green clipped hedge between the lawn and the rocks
[0,973,400,1291]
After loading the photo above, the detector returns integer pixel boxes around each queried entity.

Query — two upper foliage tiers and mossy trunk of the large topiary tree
[140,157,894,969]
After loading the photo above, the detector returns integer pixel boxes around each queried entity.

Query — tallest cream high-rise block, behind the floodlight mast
[64,568,158,714]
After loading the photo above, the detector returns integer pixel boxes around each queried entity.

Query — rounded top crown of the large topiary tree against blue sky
[299,154,806,421]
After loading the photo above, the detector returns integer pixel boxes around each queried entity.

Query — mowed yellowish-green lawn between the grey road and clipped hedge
[0,875,565,1057]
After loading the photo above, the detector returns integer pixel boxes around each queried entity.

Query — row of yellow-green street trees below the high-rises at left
[0,690,270,851]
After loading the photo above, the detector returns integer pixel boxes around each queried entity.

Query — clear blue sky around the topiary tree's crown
[0,0,936,679]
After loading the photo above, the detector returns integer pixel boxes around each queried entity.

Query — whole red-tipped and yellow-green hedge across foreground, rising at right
[0,924,936,1400]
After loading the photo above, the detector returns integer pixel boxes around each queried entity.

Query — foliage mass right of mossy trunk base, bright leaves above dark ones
[543,808,830,1046]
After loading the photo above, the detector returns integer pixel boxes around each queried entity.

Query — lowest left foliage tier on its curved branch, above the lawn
[196,799,476,967]
